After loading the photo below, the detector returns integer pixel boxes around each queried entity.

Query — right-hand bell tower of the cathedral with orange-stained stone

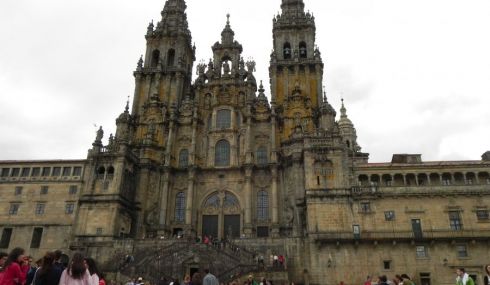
[269,0,323,141]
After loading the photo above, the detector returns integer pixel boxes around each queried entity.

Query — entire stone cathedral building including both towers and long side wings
[0,0,490,285]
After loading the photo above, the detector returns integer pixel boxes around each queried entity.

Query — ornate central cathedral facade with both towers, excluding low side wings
[75,0,368,240]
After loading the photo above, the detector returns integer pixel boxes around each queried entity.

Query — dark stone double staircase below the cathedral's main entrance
[113,239,257,283]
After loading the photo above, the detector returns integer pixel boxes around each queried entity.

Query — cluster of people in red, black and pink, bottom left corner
[0,247,106,285]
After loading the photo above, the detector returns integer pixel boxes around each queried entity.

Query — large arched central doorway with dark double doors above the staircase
[201,191,241,239]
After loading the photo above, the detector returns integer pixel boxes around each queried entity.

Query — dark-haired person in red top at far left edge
[0,247,29,285]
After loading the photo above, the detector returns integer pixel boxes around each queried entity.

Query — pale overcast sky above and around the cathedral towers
[0,0,490,162]
